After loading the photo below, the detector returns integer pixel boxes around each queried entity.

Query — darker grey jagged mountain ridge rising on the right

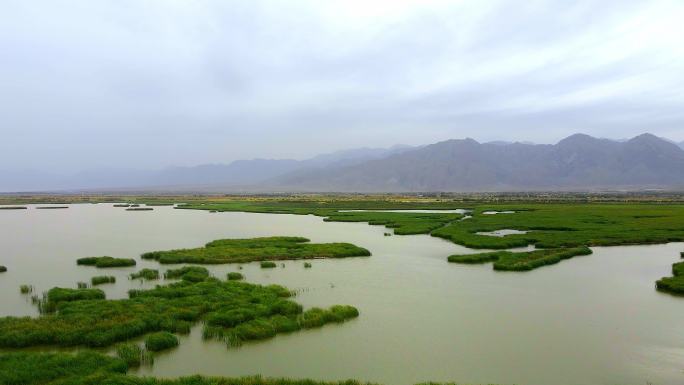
[276,134,684,192]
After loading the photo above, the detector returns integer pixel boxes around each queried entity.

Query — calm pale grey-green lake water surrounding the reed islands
[0,204,684,385]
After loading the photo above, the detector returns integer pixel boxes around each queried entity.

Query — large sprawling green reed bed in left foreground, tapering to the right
[0,272,358,348]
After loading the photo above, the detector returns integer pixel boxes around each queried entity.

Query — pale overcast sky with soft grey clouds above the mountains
[0,0,684,170]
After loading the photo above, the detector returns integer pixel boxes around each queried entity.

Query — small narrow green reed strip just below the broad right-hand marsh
[448,246,591,271]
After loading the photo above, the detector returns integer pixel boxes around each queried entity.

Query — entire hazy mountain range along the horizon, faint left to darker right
[0,134,684,192]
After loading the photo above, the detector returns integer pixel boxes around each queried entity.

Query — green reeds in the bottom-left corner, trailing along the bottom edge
[0,351,384,385]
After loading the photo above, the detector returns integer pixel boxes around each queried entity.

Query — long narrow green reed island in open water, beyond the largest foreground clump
[141,237,370,264]
